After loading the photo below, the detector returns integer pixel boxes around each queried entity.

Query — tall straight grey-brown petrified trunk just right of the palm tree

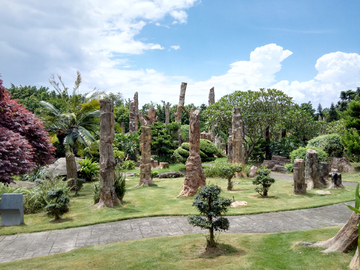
[97,98,121,208]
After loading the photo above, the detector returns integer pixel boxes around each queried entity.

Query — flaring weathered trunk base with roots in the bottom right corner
[312,212,360,269]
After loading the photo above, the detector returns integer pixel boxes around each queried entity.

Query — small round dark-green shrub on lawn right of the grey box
[45,188,70,220]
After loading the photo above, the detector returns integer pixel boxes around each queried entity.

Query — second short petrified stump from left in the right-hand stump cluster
[305,149,324,190]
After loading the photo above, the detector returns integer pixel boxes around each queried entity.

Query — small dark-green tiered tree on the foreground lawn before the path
[188,185,231,248]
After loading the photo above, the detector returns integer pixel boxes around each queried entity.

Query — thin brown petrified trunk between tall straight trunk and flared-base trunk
[138,126,154,186]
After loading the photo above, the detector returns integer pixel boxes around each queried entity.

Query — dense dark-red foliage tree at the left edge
[0,76,55,184]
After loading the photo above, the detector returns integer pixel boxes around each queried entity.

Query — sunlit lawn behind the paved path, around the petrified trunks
[0,178,355,235]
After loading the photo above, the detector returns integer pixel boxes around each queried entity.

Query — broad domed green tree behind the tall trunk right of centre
[204,88,292,162]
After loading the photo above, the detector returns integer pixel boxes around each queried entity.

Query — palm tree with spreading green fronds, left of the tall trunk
[40,71,102,186]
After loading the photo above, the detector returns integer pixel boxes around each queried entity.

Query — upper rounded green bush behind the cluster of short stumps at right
[307,134,344,158]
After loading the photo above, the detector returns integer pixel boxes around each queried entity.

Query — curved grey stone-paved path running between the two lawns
[0,174,352,263]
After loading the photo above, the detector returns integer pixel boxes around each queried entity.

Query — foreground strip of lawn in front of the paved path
[1,227,354,270]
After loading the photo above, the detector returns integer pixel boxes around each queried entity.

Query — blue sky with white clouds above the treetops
[0,0,360,108]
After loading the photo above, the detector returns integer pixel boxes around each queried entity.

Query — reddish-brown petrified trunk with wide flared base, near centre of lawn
[178,110,206,197]
